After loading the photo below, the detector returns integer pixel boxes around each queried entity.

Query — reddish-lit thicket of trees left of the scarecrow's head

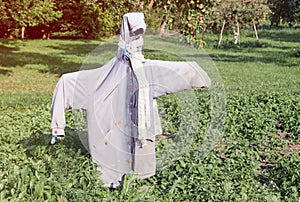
[0,0,156,39]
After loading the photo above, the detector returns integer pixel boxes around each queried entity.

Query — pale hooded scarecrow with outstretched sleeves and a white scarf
[51,13,210,188]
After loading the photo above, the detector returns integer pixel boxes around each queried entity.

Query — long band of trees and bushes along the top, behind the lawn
[0,0,300,46]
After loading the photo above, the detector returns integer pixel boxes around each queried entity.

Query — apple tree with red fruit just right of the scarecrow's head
[145,0,210,46]
